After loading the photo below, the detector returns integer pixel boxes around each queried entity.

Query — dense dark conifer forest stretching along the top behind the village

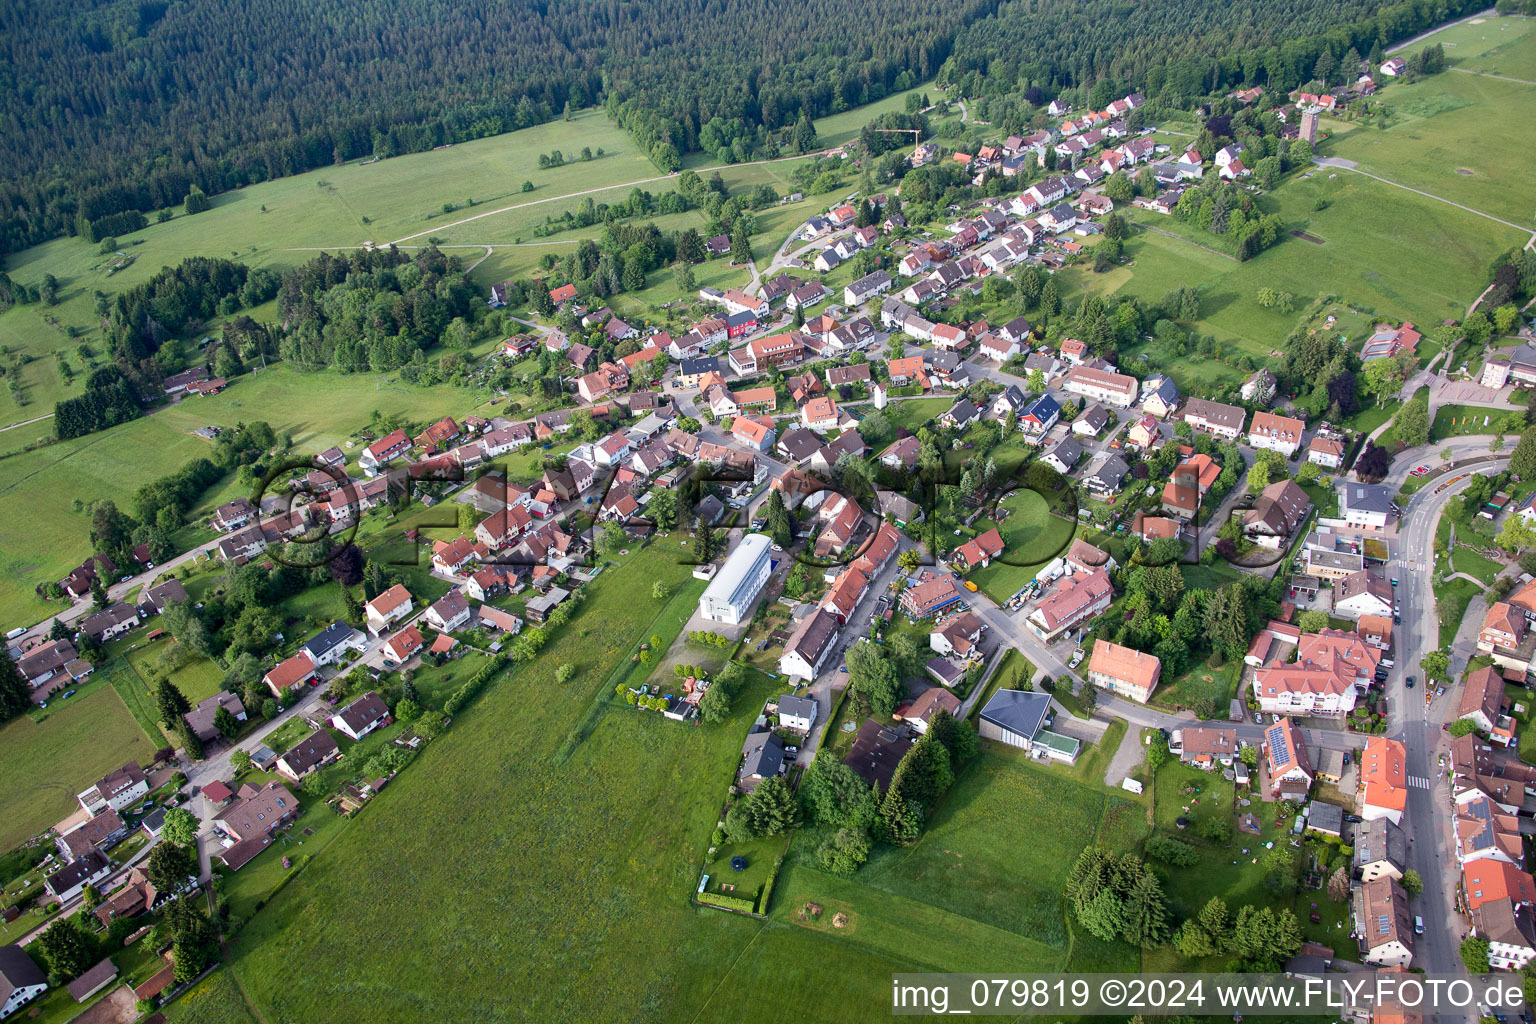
[0,0,1468,253]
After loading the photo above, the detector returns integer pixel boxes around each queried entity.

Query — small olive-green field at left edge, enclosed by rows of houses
[0,686,155,849]
